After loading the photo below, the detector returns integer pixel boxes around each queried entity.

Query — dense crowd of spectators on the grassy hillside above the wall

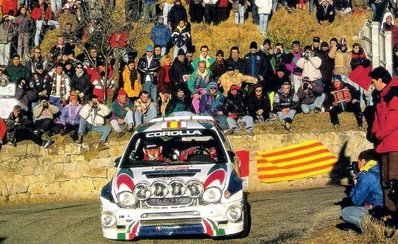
[0,0,396,149]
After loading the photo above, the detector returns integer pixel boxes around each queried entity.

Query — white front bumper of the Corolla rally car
[102,200,246,240]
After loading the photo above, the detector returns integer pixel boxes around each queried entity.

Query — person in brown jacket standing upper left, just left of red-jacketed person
[14,6,33,60]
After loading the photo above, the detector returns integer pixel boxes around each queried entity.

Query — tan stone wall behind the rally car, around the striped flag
[0,131,372,203]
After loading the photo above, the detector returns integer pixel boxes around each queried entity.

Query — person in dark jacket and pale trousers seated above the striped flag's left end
[274,82,299,130]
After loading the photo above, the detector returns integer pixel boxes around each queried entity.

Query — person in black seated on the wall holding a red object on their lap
[329,75,363,128]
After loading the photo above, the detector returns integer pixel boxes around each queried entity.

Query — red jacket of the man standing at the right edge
[372,77,398,153]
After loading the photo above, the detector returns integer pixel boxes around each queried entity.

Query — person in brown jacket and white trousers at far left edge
[0,14,14,67]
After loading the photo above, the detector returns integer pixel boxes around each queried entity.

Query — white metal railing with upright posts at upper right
[359,20,393,74]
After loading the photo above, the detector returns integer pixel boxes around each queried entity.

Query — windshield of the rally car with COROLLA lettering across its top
[120,129,226,168]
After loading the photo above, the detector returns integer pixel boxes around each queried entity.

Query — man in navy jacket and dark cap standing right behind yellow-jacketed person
[243,42,266,94]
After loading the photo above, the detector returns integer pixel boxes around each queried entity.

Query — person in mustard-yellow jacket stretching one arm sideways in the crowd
[218,66,257,96]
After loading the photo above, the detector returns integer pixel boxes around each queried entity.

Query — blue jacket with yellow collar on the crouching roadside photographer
[350,161,383,207]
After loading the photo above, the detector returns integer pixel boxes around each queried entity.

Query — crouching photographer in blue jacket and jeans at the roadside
[341,149,383,229]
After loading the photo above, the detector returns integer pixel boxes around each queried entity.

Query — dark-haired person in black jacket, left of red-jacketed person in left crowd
[70,63,93,104]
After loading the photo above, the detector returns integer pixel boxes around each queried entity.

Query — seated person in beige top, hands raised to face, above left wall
[33,99,63,143]
